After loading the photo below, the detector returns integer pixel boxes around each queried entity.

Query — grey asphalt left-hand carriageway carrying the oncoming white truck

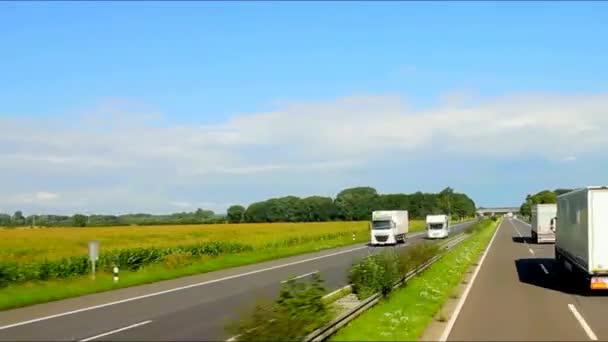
[0,222,473,341]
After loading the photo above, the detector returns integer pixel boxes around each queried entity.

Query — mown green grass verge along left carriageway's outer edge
[0,231,369,310]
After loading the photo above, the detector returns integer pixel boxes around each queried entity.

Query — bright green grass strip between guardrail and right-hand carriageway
[331,220,497,341]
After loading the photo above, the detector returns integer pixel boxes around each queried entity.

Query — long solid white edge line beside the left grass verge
[0,246,368,330]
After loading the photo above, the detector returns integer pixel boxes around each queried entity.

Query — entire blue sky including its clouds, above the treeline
[0,2,608,213]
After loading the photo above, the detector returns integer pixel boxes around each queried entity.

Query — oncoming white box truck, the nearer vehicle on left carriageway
[370,210,409,246]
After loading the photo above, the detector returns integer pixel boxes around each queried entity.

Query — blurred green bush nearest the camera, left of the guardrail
[226,274,330,341]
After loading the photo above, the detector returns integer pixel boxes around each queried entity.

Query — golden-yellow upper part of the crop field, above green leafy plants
[0,220,424,263]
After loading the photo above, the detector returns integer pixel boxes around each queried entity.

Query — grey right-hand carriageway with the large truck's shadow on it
[448,219,608,341]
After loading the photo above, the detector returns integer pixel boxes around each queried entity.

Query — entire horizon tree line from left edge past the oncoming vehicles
[0,187,475,227]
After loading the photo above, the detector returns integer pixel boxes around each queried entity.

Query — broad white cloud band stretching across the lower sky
[0,93,608,211]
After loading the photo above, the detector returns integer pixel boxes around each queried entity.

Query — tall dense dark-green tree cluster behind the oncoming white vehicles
[227,187,475,223]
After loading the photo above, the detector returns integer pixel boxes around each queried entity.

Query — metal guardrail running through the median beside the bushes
[304,233,470,342]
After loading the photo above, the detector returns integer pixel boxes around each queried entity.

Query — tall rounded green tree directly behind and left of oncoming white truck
[335,187,378,221]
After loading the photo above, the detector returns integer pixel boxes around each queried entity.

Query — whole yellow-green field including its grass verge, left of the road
[0,220,425,310]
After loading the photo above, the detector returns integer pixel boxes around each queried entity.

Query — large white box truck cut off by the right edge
[555,186,608,290]
